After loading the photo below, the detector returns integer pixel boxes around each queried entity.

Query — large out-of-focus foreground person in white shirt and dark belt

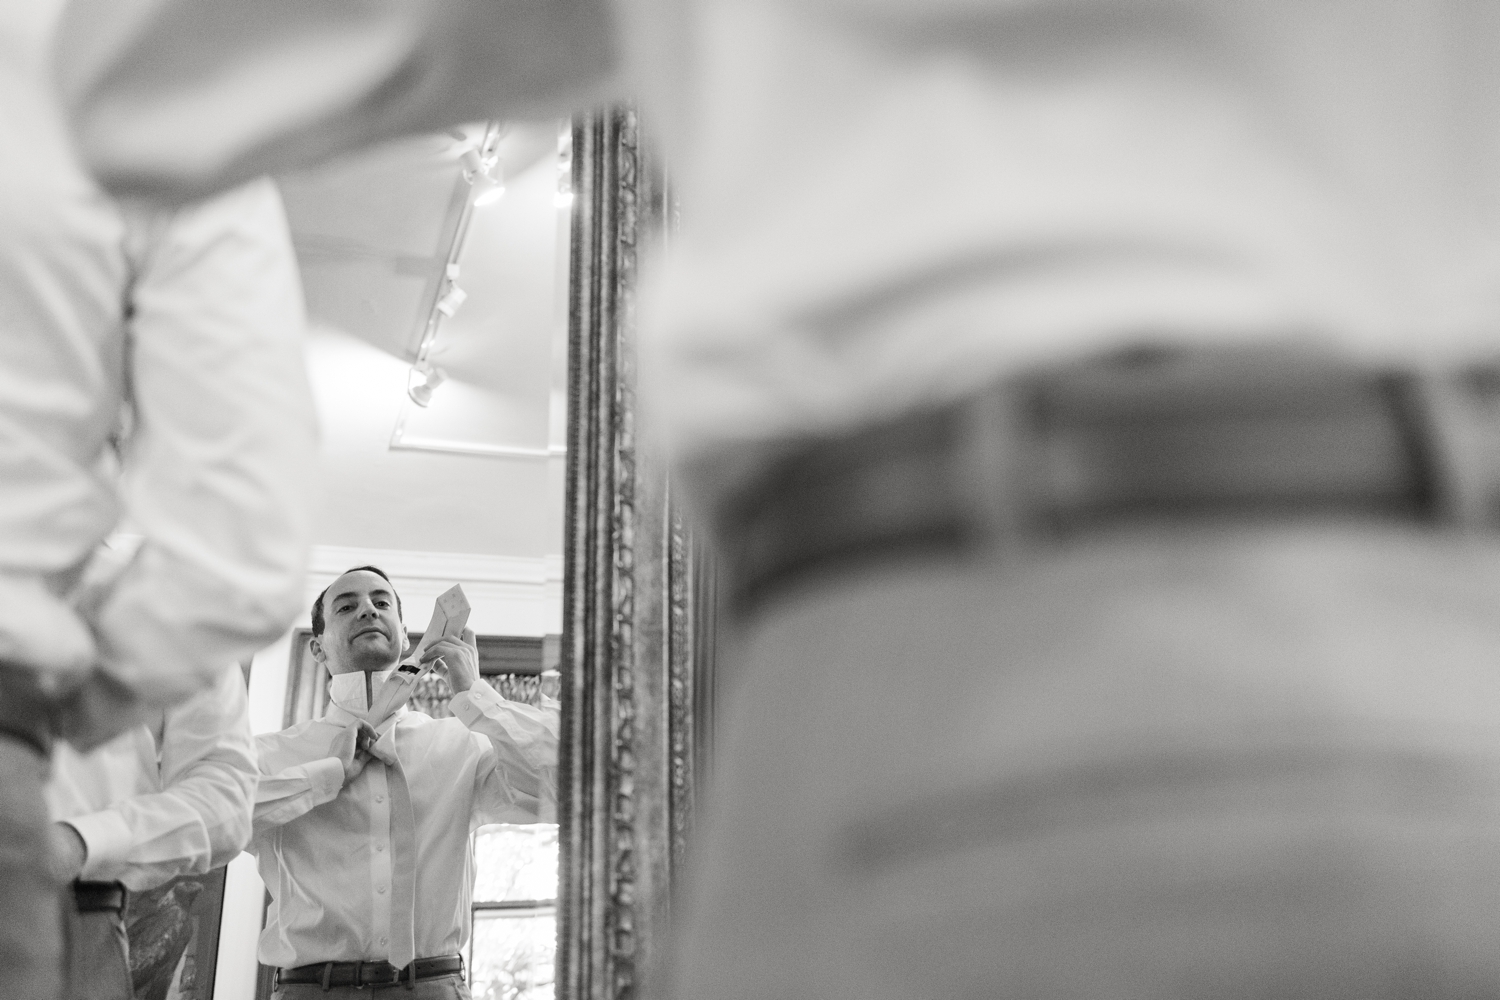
[46,0,1500,1000]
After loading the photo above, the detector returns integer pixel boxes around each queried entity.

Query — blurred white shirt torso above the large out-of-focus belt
[633,0,1500,456]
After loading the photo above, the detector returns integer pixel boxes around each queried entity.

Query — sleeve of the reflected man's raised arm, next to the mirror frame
[449,681,560,823]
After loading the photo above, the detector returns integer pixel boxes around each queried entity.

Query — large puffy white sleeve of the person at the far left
[63,180,317,745]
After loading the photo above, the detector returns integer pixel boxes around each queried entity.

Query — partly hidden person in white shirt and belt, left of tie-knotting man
[47,670,257,1000]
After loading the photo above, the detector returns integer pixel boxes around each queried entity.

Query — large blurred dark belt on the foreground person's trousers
[711,345,1500,610]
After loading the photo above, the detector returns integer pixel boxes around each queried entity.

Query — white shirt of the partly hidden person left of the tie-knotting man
[47,670,257,891]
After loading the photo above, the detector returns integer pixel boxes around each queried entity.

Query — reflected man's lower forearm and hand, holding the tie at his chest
[252,723,375,838]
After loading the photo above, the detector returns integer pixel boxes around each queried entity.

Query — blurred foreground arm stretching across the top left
[56,0,620,202]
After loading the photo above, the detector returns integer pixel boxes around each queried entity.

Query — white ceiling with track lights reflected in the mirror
[278,121,570,556]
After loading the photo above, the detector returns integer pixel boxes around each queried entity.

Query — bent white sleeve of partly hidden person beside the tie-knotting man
[68,670,257,891]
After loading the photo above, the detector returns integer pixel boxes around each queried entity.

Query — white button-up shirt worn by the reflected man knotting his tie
[249,681,558,969]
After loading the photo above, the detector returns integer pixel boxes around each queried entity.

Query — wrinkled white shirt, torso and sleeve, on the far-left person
[0,0,315,719]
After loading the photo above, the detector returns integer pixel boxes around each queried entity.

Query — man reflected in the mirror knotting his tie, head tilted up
[251,567,558,1000]
